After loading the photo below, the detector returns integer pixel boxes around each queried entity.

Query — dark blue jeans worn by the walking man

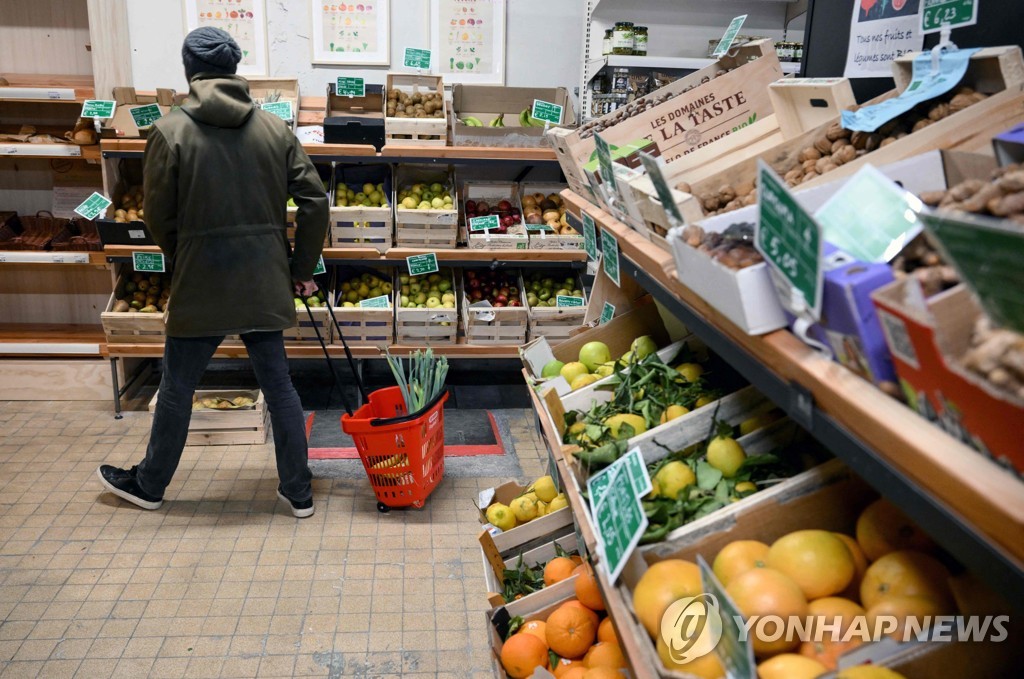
[136,332,312,502]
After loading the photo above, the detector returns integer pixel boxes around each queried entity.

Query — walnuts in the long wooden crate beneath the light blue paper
[692,87,988,215]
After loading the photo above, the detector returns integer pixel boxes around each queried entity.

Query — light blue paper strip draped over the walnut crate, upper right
[843,47,978,132]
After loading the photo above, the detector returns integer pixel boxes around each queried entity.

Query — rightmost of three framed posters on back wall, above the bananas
[430,0,505,85]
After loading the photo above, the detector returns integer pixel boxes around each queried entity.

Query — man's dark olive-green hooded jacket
[144,74,329,337]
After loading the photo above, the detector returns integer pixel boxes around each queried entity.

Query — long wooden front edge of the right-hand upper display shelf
[563,192,1024,562]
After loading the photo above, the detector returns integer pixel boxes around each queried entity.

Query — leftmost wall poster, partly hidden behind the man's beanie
[185,0,267,76]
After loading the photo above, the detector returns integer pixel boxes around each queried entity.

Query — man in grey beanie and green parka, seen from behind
[97,28,328,517]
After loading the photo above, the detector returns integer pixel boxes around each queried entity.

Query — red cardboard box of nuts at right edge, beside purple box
[871,279,1024,474]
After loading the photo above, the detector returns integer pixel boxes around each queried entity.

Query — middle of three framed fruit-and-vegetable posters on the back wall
[309,0,391,66]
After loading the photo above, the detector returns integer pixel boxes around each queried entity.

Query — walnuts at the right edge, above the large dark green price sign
[921,164,1024,224]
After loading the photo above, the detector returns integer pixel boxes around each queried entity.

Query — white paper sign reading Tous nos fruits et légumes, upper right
[843,0,925,78]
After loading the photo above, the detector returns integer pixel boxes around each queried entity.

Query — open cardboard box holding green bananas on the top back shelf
[452,83,575,147]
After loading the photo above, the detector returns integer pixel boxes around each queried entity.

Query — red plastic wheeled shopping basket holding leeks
[341,387,447,512]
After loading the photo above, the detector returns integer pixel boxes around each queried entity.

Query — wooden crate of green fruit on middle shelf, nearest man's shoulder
[329,165,394,254]
